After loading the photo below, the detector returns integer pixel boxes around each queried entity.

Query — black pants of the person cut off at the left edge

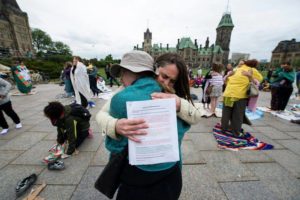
[0,101,20,129]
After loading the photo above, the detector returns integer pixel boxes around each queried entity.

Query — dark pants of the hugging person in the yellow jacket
[221,99,248,133]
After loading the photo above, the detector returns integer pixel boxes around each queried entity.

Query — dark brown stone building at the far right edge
[271,39,300,66]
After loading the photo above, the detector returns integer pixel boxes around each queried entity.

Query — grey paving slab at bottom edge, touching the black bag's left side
[72,167,112,200]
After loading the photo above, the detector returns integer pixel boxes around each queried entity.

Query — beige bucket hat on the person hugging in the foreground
[110,50,154,77]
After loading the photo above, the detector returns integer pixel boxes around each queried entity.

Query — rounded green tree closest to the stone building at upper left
[31,28,52,53]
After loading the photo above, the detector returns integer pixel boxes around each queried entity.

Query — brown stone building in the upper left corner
[0,0,33,57]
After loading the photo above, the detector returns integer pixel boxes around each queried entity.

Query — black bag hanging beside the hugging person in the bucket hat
[95,146,128,199]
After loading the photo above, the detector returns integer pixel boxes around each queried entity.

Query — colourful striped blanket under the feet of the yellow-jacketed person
[213,124,273,151]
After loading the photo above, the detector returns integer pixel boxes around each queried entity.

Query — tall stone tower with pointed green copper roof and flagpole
[216,12,234,64]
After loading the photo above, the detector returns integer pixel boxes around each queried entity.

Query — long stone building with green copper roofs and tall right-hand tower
[134,12,234,67]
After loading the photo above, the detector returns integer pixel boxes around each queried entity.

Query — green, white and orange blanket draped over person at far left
[11,66,32,94]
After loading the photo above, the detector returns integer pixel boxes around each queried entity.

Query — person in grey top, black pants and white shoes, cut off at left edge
[0,78,22,135]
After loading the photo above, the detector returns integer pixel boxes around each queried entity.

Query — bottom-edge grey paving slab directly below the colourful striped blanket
[220,181,279,200]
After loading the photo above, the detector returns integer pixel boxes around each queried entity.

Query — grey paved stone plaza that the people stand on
[0,84,300,200]
